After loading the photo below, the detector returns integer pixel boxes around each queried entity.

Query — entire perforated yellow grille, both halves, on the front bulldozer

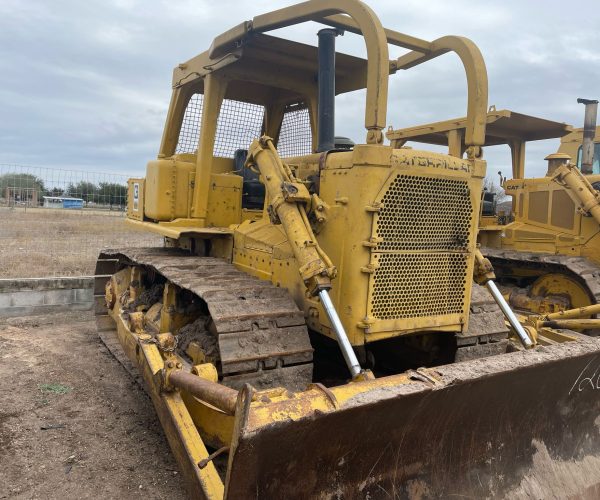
[371,175,474,320]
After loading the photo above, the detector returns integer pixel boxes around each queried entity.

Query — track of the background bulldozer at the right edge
[481,248,600,303]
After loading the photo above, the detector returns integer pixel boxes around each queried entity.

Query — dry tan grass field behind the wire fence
[0,207,162,278]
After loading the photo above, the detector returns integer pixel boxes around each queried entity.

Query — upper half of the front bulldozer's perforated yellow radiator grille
[377,175,473,254]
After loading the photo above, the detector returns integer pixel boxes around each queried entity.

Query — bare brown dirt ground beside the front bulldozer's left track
[0,312,186,499]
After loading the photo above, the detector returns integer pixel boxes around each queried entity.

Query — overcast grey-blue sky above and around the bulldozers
[0,0,600,177]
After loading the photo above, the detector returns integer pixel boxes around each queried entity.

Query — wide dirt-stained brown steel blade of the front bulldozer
[225,338,600,499]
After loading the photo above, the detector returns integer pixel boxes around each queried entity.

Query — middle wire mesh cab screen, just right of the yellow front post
[213,99,265,158]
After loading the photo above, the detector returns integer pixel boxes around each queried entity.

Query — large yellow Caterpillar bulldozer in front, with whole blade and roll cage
[95,0,600,499]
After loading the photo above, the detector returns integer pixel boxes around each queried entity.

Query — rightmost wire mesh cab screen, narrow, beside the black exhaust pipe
[277,103,312,158]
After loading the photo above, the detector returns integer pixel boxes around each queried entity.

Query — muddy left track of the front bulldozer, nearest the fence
[94,248,313,390]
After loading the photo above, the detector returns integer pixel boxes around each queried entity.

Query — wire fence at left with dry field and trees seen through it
[0,164,162,278]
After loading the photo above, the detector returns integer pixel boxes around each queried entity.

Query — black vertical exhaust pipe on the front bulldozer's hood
[317,28,340,153]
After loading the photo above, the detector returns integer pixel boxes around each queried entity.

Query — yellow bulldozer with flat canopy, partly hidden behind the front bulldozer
[387,99,600,324]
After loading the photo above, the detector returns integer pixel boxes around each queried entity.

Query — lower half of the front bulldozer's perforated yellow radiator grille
[371,253,467,320]
